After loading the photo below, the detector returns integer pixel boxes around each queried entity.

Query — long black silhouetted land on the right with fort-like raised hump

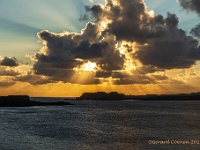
[77,92,200,101]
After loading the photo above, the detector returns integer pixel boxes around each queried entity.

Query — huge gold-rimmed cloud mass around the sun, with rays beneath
[30,0,200,84]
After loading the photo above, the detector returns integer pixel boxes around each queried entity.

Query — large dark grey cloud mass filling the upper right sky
[88,0,200,69]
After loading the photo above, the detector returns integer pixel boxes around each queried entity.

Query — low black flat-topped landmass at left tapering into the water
[0,95,71,107]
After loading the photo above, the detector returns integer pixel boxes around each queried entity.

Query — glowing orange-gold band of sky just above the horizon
[0,82,197,97]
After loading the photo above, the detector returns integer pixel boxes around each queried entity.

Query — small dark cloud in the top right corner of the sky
[179,0,200,14]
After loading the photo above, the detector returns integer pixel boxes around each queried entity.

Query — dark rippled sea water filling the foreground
[0,99,200,150]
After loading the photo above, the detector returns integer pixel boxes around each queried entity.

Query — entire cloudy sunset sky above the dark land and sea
[0,0,200,97]
